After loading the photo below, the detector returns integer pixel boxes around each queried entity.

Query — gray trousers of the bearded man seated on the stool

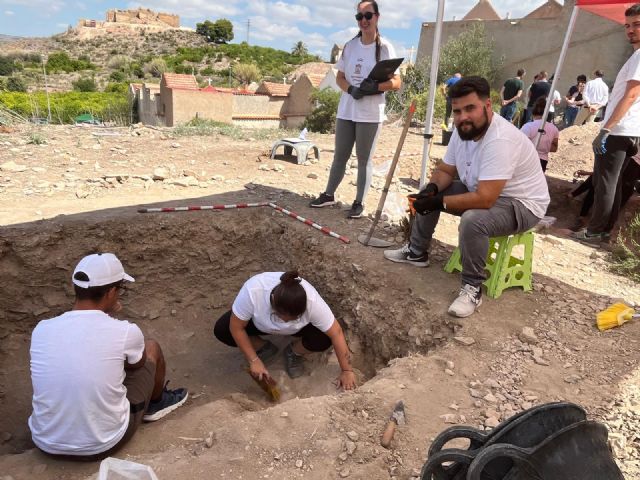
[409,181,540,287]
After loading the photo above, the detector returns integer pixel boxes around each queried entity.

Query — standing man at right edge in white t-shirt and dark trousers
[574,3,640,244]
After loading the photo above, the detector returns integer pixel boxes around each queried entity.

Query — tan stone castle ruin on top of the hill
[72,8,181,39]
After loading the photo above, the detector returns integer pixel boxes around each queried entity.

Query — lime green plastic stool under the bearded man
[444,230,533,298]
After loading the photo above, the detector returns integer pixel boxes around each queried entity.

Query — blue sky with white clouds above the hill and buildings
[0,0,564,59]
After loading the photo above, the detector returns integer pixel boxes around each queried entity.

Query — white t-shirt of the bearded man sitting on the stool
[444,114,549,218]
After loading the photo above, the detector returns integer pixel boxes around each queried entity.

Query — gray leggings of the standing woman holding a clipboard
[325,118,382,202]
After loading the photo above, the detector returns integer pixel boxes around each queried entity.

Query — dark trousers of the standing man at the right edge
[587,135,640,233]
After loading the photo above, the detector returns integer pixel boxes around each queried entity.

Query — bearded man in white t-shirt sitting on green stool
[384,77,549,317]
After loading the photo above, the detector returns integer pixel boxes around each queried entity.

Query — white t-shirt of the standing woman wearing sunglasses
[336,37,396,123]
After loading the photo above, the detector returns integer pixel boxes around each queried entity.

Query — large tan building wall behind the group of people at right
[417,0,632,92]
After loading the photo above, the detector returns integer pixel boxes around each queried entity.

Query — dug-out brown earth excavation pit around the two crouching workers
[0,208,451,453]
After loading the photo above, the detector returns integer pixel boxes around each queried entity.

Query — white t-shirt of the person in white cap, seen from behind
[29,310,144,455]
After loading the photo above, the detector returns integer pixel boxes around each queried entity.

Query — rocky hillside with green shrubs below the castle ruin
[0,29,317,91]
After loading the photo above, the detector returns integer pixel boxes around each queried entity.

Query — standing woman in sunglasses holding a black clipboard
[309,0,401,218]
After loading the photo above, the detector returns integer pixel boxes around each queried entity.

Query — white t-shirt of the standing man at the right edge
[602,49,640,137]
